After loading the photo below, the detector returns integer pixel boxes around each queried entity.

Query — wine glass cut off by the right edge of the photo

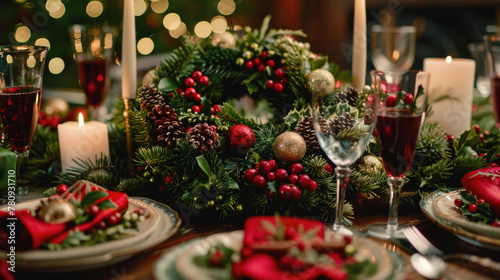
[484,35,500,128]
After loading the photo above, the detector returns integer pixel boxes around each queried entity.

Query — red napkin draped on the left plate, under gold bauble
[0,181,128,250]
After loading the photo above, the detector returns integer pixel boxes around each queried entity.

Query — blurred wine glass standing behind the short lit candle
[69,24,118,120]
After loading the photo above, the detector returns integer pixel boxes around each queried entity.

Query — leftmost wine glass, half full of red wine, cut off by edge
[0,46,48,194]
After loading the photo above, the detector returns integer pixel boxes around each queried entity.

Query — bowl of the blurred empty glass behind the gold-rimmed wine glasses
[370,25,417,70]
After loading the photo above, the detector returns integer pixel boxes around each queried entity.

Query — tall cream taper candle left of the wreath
[122,0,137,99]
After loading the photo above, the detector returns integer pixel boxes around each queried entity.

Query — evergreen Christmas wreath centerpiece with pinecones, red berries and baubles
[42,17,499,223]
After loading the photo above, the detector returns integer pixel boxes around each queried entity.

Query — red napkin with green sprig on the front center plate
[232,216,348,280]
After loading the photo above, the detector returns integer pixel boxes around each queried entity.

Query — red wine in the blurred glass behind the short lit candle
[78,58,107,108]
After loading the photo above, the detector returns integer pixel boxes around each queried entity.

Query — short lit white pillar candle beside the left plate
[57,113,109,172]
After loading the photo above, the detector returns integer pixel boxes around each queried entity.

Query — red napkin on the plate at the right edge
[462,167,500,218]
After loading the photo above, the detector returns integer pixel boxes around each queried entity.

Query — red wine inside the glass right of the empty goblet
[376,108,422,178]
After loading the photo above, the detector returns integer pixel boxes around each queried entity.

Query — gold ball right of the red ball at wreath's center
[273,131,306,163]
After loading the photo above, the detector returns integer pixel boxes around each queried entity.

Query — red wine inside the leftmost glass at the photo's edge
[0,87,42,153]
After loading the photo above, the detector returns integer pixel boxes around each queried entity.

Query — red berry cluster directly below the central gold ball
[245,162,318,200]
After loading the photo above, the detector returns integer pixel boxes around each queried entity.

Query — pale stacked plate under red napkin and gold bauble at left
[0,198,181,272]
